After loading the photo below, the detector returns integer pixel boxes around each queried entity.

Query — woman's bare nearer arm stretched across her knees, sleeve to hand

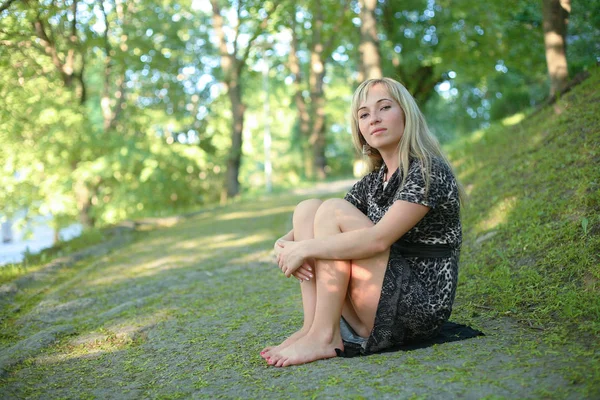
[276,200,430,276]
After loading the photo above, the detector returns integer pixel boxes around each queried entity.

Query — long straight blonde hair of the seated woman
[351,78,465,203]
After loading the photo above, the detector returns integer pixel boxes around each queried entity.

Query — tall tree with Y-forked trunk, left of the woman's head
[210,0,281,197]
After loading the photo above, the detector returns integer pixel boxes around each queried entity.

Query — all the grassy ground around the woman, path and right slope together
[0,70,600,399]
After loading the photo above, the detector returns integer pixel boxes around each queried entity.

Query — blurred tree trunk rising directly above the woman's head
[358,0,383,80]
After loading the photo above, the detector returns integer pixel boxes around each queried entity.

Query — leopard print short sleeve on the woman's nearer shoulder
[394,159,443,208]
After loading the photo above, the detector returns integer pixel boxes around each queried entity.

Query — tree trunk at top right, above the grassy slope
[542,0,571,96]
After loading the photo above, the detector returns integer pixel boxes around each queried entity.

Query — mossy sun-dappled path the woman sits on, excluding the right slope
[0,182,600,399]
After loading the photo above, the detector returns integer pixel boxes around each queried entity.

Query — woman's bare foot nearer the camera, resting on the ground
[267,331,344,367]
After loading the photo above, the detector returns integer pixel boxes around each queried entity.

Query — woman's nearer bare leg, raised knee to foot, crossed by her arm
[268,199,389,367]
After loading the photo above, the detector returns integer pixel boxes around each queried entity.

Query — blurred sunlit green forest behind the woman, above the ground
[0,0,600,236]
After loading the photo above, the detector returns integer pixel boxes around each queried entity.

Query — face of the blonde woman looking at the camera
[357,84,404,153]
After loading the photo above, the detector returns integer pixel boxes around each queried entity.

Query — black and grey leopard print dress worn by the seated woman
[342,158,462,354]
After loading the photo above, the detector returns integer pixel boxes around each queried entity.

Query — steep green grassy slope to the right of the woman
[450,71,600,338]
